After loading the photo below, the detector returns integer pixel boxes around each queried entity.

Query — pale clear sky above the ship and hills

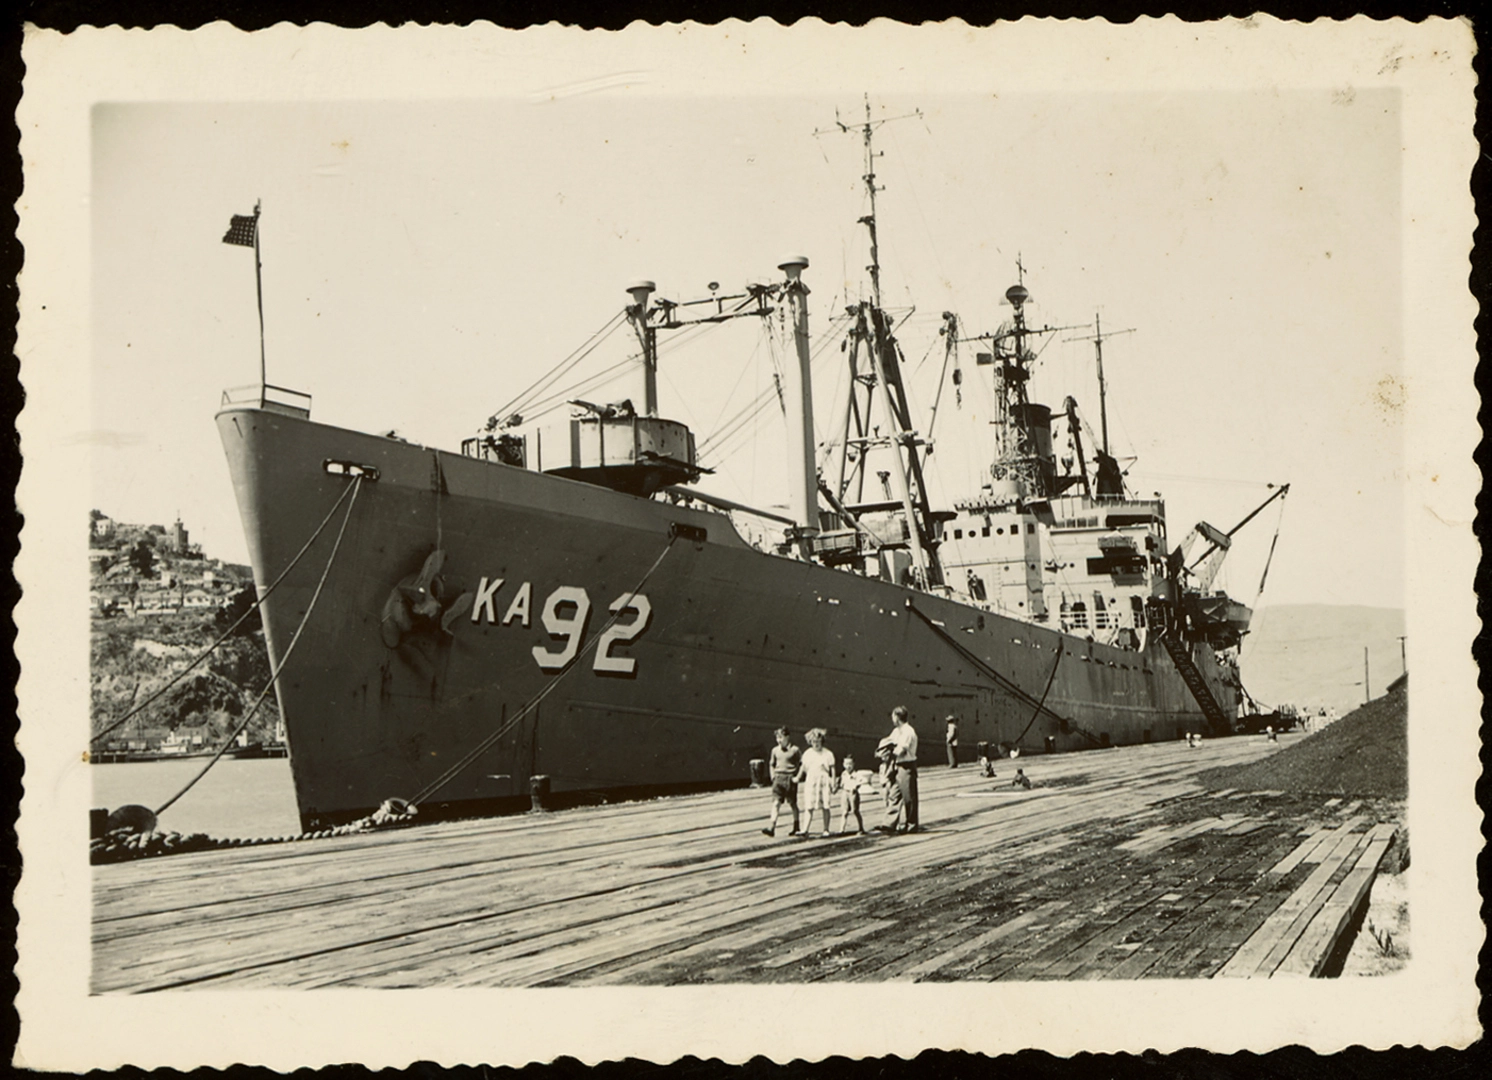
[90,87,1405,607]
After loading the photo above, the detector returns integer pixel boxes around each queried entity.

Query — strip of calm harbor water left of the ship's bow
[90,758,300,840]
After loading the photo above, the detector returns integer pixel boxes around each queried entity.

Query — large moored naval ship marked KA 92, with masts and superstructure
[216,106,1288,829]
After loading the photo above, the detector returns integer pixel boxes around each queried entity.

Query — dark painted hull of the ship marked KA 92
[218,407,1237,828]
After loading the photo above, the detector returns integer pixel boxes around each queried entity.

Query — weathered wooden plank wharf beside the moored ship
[93,735,1397,993]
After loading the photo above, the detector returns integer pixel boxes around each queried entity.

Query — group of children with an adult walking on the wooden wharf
[762,728,904,837]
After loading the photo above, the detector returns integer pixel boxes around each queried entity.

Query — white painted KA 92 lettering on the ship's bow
[471,577,652,676]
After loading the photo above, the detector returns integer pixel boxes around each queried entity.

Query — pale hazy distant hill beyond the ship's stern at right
[1240,604,1404,713]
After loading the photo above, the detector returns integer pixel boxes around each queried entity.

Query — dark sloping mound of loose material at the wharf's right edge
[1198,685,1408,800]
